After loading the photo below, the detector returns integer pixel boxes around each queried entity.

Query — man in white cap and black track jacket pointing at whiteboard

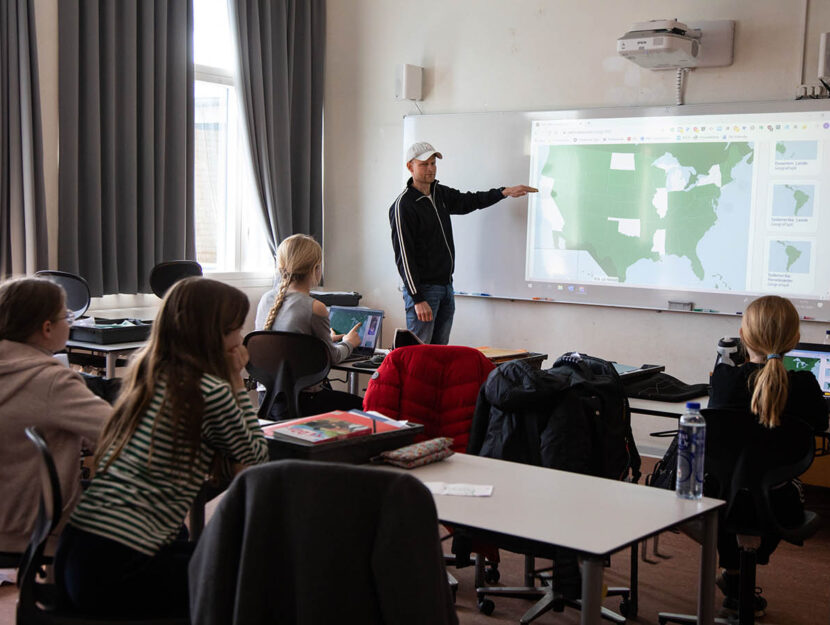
[389,141,537,345]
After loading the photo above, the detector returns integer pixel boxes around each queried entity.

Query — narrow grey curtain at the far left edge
[0,0,48,278]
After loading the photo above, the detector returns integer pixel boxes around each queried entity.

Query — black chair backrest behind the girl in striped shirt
[17,427,63,623]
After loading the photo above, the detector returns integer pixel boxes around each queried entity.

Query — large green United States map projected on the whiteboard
[531,142,753,289]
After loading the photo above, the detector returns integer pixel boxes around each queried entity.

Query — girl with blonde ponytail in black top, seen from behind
[709,295,828,612]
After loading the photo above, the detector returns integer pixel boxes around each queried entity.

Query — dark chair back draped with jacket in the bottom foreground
[189,460,458,625]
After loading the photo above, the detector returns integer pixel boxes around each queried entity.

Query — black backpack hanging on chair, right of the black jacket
[543,352,640,482]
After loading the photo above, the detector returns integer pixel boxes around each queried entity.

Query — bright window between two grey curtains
[193,0,274,272]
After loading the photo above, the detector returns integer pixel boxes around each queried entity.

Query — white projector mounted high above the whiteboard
[617,20,700,69]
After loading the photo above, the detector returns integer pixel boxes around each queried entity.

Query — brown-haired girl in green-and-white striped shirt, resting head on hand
[55,278,268,617]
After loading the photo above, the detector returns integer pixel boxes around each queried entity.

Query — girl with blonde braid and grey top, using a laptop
[255,234,363,421]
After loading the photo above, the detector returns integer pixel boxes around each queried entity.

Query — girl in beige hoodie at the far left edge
[0,278,112,553]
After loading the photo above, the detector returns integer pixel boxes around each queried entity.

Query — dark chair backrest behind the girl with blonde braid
[244,330,331,419]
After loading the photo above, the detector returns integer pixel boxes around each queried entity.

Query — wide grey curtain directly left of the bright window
[58,0,195,295]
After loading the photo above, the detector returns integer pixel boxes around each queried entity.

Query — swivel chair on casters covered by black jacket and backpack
[467,355,639,624]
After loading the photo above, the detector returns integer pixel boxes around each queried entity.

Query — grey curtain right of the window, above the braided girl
[228,0,326,253]
